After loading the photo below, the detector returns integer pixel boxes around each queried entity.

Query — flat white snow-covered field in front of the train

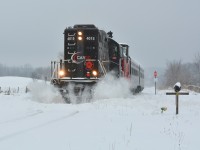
[0,77,200,150]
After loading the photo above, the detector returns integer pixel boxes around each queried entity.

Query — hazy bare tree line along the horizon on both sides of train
[0,53,200,88]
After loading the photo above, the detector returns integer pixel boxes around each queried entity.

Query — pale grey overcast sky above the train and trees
[0,0,200,67]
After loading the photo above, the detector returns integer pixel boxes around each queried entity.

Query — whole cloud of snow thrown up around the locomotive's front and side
[28,74,131,104]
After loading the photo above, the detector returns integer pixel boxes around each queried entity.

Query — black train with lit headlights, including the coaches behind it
[51,24,144,102]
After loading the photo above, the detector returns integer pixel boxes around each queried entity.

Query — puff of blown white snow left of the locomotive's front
[28,82,64,103]
